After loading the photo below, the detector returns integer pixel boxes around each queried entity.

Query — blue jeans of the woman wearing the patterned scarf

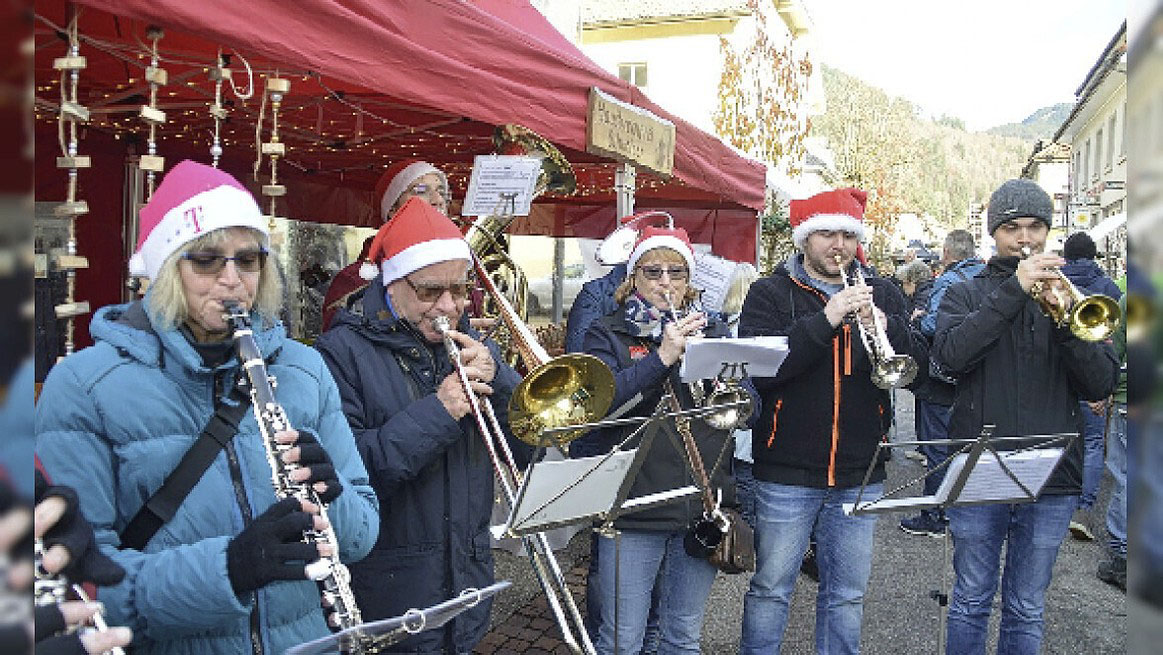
[598,531,716,655]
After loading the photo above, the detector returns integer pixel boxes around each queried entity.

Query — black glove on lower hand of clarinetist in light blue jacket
[226,498,319,596]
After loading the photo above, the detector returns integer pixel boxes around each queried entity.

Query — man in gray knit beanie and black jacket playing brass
[930,179,1119,655]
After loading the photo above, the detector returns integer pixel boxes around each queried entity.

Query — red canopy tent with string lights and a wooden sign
[36,0,764,344]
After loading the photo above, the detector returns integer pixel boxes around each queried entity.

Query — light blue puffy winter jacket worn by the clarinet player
[36,297,379,655]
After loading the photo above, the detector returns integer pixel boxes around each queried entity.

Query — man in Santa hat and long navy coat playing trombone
[315,198,520,653]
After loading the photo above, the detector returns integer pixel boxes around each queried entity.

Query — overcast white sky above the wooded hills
[804,0,1127,130]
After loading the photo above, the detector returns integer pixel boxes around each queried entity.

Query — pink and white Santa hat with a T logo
[129,159,270,279]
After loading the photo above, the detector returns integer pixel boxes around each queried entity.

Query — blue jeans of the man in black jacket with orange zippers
[740,480,884,655]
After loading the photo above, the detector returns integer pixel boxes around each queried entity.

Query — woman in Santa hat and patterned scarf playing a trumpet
[584,227,755,654]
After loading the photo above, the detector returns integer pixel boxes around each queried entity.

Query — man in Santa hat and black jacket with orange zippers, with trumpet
[739,188,926,655]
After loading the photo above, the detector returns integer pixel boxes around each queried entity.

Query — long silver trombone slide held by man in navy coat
[433,316,597,655]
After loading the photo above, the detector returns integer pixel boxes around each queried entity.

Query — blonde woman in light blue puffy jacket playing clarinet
[35,162,379,654]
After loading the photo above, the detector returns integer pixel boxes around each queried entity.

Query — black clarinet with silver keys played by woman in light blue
[222,302,385,655]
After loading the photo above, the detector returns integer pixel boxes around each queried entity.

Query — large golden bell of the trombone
[508,353,614,447]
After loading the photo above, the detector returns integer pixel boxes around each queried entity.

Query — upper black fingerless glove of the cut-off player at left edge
[36,469,126,586]
